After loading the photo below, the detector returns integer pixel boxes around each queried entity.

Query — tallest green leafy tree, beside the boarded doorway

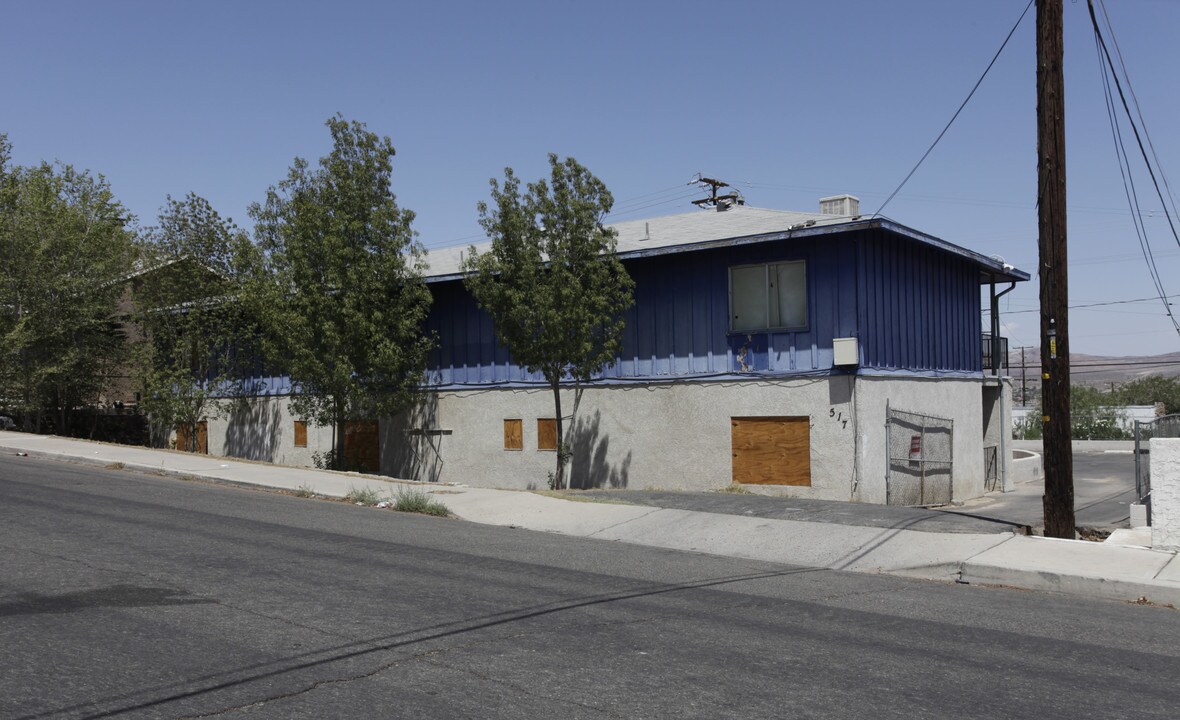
[250,116,431,469]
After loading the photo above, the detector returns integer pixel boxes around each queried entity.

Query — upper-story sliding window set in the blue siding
[729,260,807,332]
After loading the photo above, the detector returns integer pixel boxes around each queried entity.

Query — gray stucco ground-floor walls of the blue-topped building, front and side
[195,375,1010,503]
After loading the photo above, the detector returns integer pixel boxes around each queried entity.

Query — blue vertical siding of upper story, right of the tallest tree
[427,230,982,385]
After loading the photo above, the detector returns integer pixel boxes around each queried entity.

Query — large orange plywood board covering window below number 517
[730,417,811,486]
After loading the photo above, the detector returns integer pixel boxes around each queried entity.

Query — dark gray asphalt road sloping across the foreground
[0,457,1180,720]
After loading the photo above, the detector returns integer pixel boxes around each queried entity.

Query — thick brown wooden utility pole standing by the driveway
[1036,0,1074,539]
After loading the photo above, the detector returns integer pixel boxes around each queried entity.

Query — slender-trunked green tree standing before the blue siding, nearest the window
[464,153,635,489]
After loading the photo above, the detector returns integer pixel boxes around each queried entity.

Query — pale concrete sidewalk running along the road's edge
[0,431,1180,606]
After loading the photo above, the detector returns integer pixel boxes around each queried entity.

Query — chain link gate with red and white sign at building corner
[885,404,955,506]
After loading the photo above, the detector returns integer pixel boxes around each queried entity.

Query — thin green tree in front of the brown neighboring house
[132,194,258,452]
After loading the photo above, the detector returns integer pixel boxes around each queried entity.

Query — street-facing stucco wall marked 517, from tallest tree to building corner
[382,377,854,499]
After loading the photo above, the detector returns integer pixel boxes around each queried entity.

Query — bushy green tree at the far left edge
[0,135,133,433]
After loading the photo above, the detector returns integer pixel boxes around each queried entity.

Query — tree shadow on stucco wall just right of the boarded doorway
[381,392,451,483]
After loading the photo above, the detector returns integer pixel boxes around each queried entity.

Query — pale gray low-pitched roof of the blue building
[426,205,1029,282]
